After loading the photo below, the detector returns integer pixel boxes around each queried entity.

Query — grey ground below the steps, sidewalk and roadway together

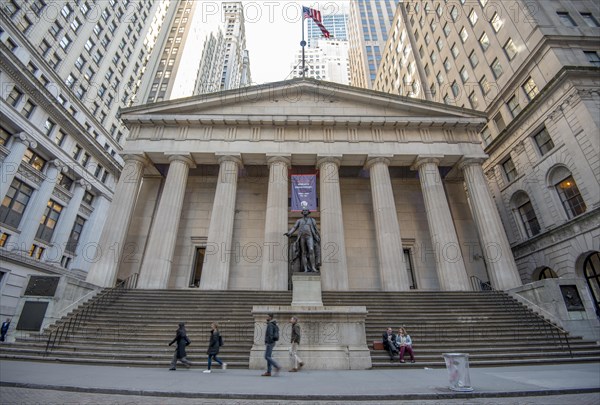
[0,360,600,405]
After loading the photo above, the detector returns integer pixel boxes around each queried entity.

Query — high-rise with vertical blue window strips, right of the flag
[348,0,398,88]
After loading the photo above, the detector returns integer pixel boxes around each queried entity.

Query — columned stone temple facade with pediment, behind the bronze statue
[87,79,522,291]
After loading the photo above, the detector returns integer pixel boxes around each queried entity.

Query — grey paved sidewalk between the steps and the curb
[0,361,600,401]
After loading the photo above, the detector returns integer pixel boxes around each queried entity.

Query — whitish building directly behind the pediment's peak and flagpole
[292,39,350,84]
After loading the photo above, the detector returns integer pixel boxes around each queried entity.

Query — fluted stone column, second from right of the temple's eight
[412,156,471,291]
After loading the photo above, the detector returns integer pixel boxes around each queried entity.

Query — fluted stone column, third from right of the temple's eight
[366,156,410,291]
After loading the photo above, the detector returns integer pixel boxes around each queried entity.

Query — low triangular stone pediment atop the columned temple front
[121,79,485,125]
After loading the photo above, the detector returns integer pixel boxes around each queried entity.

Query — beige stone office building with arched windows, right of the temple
[375,0,600,313]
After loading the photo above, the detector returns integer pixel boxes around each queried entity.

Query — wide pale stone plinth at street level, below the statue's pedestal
[249,306,371,371]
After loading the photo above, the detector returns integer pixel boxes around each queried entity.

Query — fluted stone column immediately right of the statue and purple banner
[317,156,348,291]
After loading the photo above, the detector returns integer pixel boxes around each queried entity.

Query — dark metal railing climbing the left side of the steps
[44,273,138,355]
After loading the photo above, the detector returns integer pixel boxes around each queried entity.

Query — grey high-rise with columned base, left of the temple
[0,0,168,329]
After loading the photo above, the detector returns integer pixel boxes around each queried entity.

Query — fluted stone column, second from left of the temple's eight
[137,155,194,289]
